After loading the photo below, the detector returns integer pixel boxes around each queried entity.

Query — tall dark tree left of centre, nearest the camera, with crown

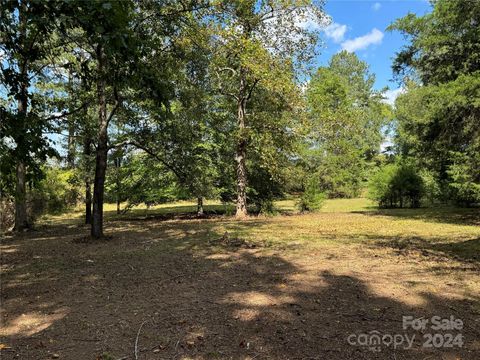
[63,1,139,238]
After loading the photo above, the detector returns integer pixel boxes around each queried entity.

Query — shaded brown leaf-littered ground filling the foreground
[0,221,480,359]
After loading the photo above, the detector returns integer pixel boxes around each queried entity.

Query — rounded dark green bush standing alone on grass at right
[368,164,424,208]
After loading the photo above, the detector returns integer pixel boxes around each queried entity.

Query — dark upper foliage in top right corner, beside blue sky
[389,0,480,85]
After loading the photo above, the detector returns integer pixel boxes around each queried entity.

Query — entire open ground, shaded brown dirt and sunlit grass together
[0,205,480,360]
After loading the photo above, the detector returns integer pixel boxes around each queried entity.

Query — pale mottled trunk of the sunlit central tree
[235,69,247,218]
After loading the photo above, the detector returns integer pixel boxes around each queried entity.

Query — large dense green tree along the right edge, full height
[390,0,480,203]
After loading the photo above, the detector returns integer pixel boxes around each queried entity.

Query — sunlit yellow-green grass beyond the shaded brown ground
[40,198,480,260]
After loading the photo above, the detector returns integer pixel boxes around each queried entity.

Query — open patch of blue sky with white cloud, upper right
[316,0,431,103]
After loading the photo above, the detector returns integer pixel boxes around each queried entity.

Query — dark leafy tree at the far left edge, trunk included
[0,0,74,231]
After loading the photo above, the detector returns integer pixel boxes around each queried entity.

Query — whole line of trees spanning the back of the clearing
[0,0,480,238]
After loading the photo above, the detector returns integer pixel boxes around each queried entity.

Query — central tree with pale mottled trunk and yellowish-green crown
[212,0,326,218]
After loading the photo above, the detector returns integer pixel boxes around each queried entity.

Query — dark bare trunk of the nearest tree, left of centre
[91,45,108,238]
